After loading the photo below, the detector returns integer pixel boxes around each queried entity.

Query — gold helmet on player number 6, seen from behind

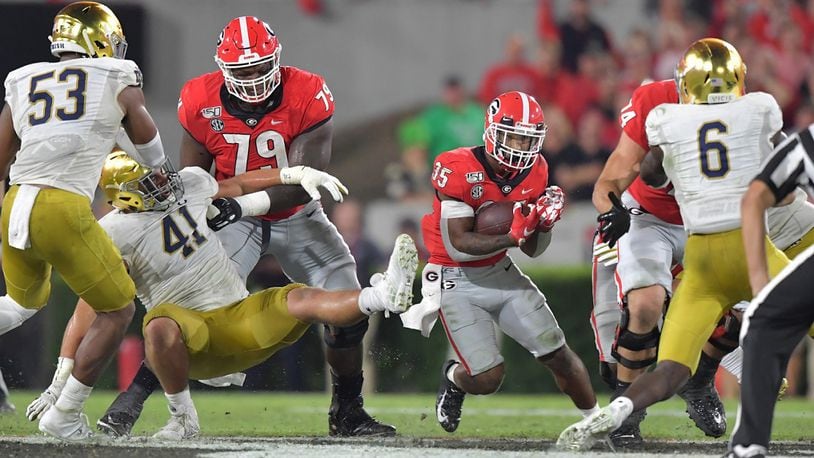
[675,38,746,104]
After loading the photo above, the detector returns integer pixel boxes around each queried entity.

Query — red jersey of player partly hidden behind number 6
[619,80,683,224]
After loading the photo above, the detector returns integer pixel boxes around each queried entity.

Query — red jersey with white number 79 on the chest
[178,67,334,221]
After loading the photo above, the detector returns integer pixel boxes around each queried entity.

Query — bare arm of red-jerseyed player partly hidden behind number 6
[593,132,647,213]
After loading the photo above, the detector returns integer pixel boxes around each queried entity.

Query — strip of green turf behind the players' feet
[0,391,814,441]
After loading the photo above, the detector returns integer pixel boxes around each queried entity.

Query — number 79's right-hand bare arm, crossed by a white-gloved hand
[266,119,334,212]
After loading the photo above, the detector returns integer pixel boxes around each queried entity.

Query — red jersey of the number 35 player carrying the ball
[421,146,548,267]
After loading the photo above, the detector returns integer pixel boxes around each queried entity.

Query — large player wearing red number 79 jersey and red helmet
[95,16,396,436]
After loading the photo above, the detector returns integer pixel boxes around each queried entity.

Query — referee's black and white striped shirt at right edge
[755,124,814,202]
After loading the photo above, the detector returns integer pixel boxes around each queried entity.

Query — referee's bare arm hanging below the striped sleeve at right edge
[741,180,775,296]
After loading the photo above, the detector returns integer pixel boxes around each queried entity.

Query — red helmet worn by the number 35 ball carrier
[483,91,548,171]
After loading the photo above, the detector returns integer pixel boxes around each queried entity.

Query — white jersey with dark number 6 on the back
[646,92,783,234]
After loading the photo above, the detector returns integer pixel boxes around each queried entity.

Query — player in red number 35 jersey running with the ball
[422,92,597,432]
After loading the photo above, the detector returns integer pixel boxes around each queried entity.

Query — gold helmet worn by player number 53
[48,2,127,59]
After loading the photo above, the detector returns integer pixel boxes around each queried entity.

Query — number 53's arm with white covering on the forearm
[118,86,167,168]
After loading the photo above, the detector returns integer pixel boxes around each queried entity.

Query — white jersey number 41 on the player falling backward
[99,167,249,311]
